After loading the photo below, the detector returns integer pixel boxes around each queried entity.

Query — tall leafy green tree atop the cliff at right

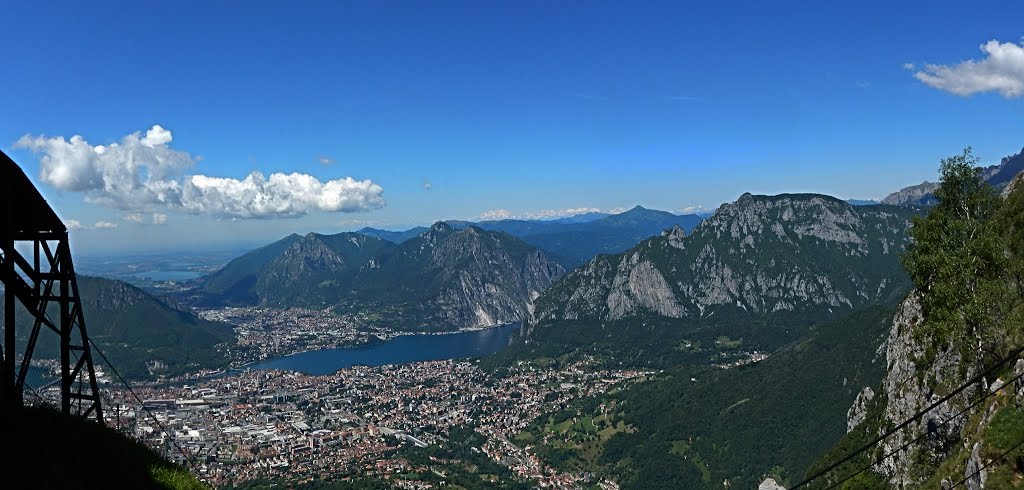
[903,147,1011,354]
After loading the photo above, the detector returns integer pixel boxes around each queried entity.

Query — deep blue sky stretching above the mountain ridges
[0,1,1024,256]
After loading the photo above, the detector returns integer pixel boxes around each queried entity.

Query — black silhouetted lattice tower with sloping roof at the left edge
[0,147,103,422]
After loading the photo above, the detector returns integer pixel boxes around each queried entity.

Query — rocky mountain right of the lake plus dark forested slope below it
[485,193,920,488]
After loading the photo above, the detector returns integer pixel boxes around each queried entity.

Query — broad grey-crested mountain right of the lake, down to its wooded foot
[503,194,914,360]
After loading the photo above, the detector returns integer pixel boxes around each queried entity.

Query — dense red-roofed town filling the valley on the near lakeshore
[99,361,644,488]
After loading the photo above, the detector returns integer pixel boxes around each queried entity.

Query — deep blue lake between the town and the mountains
[247,323,520,375]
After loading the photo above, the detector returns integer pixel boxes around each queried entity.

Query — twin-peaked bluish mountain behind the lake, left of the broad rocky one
[198,222,564,330]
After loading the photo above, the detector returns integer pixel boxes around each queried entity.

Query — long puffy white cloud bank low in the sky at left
[15,126,384,219]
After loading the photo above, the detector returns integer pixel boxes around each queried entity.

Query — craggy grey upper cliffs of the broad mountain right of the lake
[535,194,910,323]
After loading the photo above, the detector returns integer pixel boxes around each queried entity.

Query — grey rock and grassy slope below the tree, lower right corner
[811,293,1024,490]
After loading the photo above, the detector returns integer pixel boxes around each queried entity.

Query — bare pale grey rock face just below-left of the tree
[873,293,983,488]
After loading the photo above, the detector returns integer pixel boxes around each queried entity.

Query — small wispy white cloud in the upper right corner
[913,40,1024,98]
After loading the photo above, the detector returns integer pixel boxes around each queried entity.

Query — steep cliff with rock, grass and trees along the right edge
[809,168,1024,490]
